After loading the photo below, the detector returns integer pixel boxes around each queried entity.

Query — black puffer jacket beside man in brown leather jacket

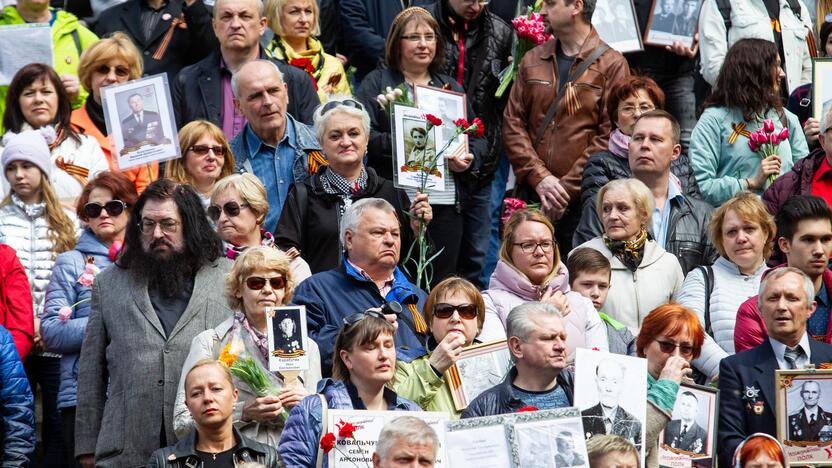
[425,0,514,180]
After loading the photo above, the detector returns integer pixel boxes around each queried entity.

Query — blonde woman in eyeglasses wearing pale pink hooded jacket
[479,210,609,363]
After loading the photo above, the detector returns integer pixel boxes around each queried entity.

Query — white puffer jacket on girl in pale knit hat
[0,195,80,317]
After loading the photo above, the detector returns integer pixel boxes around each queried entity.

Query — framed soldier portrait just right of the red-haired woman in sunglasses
[659,384,719,468]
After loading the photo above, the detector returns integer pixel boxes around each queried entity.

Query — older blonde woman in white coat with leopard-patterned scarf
[577,179,685,335]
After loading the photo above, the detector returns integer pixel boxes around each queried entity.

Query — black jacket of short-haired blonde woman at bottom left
[147,427,286,468]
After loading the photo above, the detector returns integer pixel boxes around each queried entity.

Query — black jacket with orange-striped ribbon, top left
[95,0,219,83]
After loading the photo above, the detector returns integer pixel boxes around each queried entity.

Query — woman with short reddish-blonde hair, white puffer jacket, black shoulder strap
[679,192,777,378]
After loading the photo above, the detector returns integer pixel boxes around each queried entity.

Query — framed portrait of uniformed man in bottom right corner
[774,369,832,466]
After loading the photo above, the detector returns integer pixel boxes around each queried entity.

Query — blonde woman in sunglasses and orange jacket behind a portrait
[70,32,159,193]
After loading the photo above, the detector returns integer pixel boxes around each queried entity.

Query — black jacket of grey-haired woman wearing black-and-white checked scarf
[274,166,413,274]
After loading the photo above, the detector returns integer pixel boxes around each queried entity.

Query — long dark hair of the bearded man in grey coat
[117,179,222,268]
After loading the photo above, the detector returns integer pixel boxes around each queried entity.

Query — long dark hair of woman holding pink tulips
[704,39,783,121]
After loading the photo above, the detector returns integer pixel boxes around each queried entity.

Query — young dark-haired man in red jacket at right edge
[734,195,832,352]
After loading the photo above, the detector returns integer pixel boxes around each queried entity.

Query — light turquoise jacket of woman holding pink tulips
[690,107,809,207]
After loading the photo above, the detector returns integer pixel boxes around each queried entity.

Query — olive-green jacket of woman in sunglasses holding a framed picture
[394,354,462,419]
